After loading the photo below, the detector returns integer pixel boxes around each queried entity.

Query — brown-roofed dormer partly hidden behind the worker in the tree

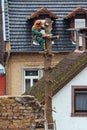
[28,8,58,48]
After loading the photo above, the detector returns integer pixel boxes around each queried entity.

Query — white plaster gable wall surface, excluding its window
[52,67,87,130]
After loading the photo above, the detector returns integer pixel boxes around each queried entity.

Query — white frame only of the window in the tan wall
[23,67,44,92]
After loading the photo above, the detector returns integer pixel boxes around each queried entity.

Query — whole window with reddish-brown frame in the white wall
[71,86,87,116]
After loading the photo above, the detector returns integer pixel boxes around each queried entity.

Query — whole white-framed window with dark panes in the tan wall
[23,68,43,92]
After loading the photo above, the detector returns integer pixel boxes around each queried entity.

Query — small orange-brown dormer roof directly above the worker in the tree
[28,8,58,19]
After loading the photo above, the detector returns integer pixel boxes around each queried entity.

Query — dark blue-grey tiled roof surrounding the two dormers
[5,0,87,52]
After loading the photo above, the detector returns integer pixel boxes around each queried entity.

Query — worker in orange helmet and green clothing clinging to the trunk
[32,20,47,50]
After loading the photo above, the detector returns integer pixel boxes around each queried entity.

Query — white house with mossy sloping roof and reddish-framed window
[24,52,87,130]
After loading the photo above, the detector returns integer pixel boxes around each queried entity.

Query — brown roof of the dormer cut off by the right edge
[64,7,87,19]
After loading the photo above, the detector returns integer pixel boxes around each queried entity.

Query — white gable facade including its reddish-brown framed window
[52,67,87,130]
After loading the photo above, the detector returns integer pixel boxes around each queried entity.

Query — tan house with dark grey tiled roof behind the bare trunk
[2,0,86,95]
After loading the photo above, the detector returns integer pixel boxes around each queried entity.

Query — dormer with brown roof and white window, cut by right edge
[64,7,87,50]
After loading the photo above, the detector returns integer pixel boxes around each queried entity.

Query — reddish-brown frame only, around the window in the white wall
[71,85,87,117]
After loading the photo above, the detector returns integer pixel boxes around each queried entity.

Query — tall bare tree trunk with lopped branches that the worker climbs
[44,18,59,129]
